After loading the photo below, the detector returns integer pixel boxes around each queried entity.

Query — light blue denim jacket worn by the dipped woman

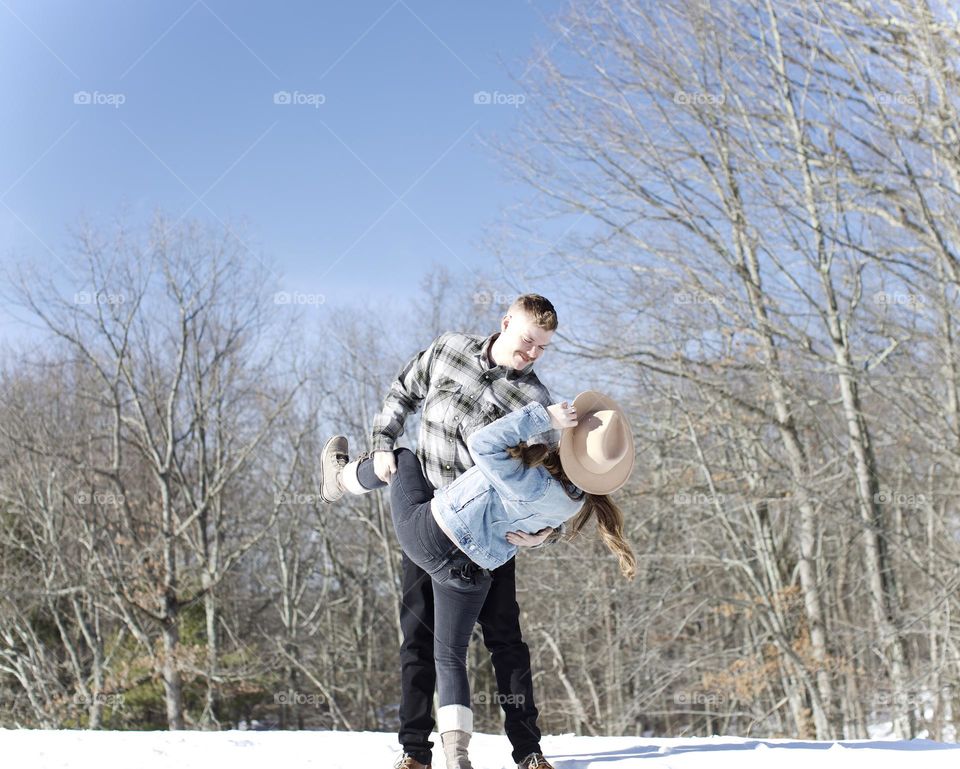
[433,401,583,569]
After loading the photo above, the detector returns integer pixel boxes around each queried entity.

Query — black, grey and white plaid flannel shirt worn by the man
[373,332,565,542]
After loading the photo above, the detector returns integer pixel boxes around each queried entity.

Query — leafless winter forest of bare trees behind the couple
[0,0,960,741]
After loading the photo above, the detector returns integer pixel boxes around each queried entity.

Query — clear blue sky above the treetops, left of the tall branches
[0,0,562,318]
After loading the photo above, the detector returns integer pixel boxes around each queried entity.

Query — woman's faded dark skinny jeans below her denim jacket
[357,449,491,724]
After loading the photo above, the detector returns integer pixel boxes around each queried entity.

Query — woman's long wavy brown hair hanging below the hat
[507,443,637,579]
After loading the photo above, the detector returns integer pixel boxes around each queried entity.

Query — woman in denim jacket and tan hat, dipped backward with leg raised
[321,391,636,769]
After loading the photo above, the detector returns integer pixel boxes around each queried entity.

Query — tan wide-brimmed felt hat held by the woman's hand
[560,390,635,494]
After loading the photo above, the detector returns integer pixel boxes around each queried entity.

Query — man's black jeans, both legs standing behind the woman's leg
[357,450,540,764]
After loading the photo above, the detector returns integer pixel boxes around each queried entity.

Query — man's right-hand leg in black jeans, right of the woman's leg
[478,558,541,763]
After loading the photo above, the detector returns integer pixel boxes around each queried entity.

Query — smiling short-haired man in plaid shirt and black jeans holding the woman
[324,294,562,769]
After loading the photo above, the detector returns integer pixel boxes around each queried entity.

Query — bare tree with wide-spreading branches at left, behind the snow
[2,217,303,728]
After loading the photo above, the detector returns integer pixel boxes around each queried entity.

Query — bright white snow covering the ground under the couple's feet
[0,729,960,769]
